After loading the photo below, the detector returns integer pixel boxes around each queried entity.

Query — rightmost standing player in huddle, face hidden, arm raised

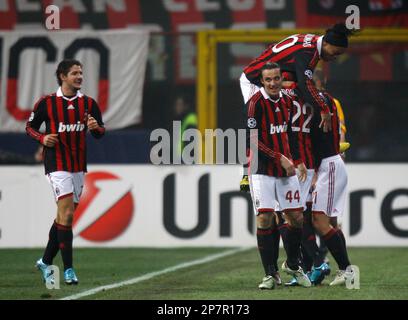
[311,92,353,285]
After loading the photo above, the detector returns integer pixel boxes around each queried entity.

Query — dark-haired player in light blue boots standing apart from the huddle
[26,60,105,284]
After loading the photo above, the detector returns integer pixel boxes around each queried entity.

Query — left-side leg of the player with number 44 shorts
[249,174,279,289]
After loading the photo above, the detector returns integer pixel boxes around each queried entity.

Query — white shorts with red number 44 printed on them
[249,174,303,215]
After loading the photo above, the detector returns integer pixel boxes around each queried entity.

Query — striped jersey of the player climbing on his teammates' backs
[244,34,329,113]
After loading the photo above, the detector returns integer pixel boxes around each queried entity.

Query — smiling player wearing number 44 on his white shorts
[246,63,311,289]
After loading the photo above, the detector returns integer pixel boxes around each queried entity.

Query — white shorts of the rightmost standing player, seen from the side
[312,155,347,217]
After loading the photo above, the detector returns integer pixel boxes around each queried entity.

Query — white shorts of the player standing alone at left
[47,171,84,203]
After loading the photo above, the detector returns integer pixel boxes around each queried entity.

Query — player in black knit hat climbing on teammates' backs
[240,23,352,191]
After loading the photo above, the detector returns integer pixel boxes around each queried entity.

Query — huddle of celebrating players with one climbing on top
[240,24,354,289]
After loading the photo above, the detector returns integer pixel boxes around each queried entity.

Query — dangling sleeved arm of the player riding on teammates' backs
[295,52,331,132]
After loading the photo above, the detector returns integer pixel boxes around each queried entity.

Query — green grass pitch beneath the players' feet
[0,248,408,300]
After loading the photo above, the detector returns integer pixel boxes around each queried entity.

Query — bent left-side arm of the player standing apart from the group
[26,98,58,148]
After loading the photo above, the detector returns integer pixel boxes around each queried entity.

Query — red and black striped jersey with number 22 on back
[282,83,315,169]
